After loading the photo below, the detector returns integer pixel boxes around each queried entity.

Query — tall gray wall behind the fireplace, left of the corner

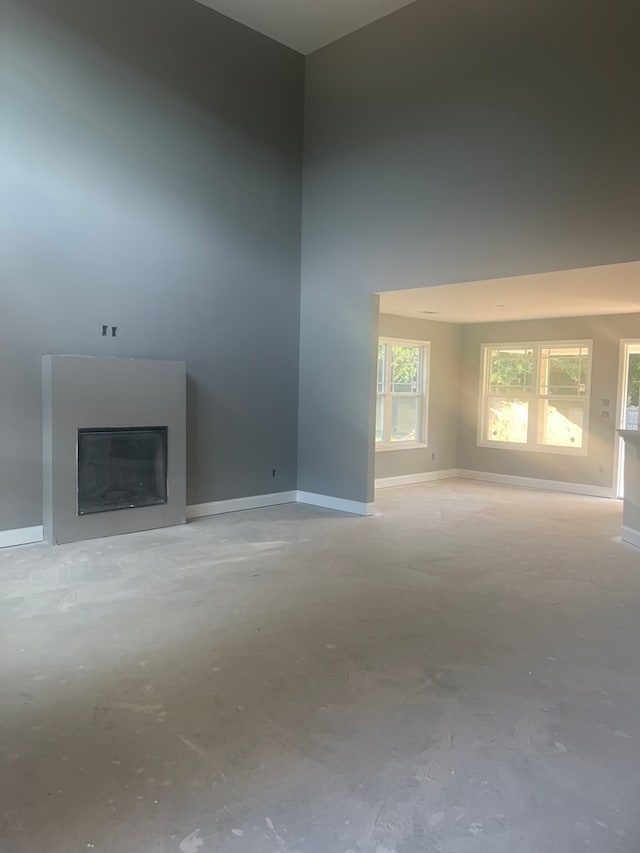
[0,0,304,529]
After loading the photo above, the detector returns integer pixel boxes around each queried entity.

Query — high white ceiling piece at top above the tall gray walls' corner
[190,0,415,53]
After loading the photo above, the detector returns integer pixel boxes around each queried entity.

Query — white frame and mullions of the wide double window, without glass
[477,340,593,456]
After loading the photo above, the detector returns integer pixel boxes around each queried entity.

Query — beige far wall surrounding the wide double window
[458,312,640,487]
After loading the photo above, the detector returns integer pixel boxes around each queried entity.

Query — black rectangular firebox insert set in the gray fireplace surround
[78,426,167,515]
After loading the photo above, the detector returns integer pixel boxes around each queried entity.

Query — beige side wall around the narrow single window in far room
[375,314,460,479]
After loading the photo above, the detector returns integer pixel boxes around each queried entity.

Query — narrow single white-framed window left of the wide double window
[376,338,429,450]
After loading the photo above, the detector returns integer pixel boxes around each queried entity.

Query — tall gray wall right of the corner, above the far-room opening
[298,0,640,501]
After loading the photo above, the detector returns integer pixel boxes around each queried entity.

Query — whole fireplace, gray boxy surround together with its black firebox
[42,355,186,544]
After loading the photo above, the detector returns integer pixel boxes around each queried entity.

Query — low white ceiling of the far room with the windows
[380,261,640,323]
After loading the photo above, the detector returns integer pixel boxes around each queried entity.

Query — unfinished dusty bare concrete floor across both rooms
[0,481,640,853]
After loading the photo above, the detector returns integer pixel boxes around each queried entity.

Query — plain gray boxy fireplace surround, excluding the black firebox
[42,355,186,544]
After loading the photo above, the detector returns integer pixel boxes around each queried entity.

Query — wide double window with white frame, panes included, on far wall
[478,341,591,454]
